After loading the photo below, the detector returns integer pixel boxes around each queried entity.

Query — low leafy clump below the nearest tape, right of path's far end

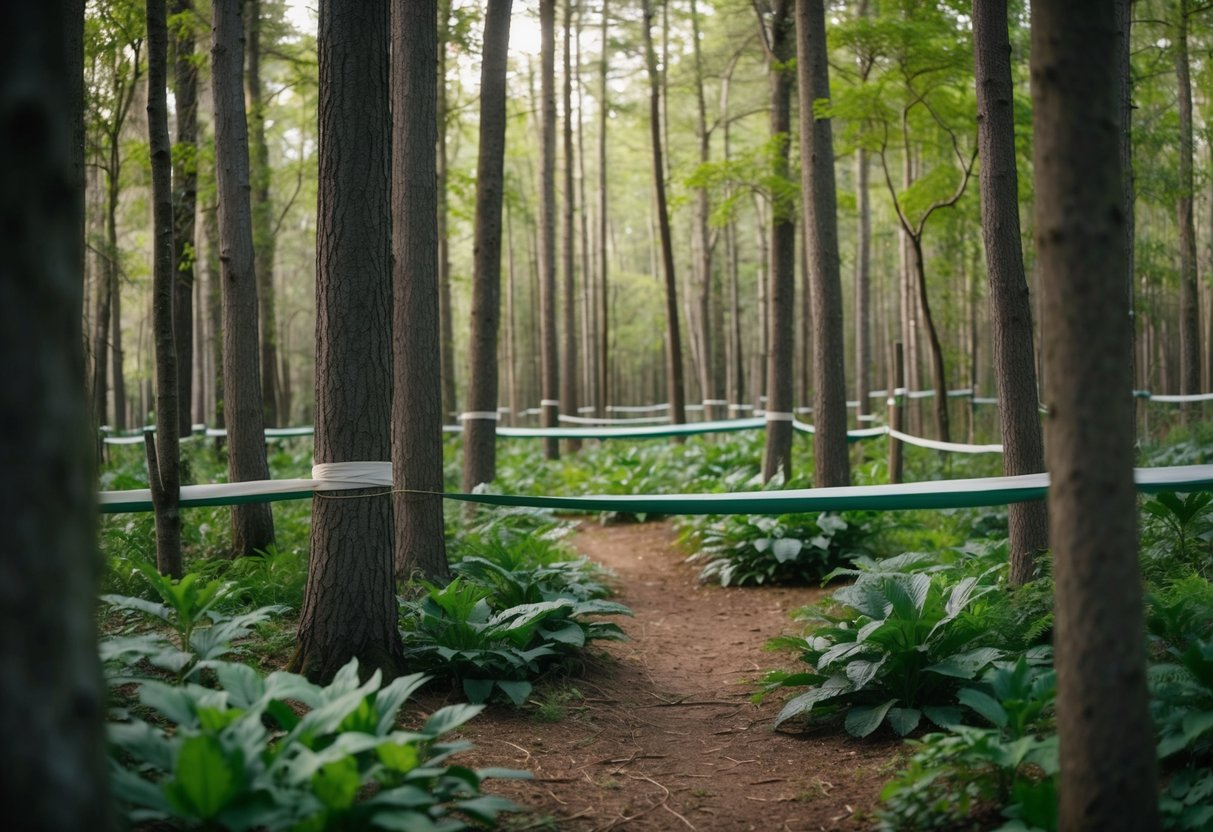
[683,512,877,586]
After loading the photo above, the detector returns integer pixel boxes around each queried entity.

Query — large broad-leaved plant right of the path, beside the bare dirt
[767,574,1002,736]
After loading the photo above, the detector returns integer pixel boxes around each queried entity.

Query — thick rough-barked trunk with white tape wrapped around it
[290,0,405,682]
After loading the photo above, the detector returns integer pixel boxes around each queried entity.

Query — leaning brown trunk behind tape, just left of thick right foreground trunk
[973,0,1049,586]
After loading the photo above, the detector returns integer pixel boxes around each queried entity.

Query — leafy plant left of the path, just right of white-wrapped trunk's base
[402,579,631,705]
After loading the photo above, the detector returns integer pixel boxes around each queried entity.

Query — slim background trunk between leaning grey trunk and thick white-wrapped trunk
[245,0,280,426]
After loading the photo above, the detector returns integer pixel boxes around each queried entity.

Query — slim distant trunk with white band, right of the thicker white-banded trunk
[539,0,560,460]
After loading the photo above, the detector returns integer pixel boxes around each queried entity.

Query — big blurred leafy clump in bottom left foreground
[109,661,520,832]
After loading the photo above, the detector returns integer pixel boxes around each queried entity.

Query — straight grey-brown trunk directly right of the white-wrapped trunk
[391,0,453,584]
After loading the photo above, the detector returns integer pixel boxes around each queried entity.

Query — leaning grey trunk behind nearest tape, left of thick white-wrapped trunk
[211,0,274,555]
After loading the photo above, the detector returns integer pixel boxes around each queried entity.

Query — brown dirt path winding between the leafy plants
[448,523,900,832]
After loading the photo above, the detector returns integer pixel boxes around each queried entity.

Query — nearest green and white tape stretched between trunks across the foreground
[99,466,1213,514]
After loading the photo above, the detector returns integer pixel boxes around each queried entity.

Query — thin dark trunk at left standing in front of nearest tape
[144,0,180,577]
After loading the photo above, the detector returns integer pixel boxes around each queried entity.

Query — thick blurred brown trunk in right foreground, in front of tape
[1031,0,1158,832]
